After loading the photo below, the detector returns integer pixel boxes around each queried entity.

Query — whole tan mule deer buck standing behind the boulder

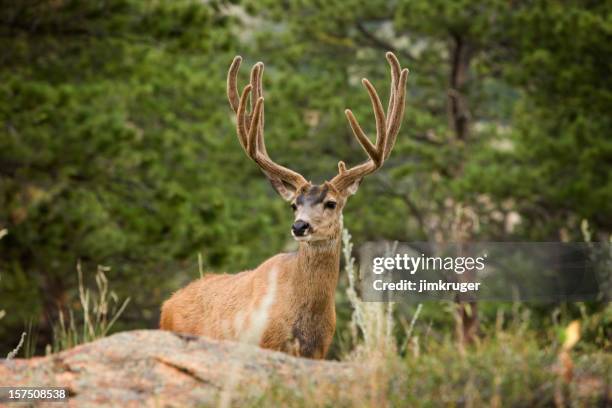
[160,52,408,358]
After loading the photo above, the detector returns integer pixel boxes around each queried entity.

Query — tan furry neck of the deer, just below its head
[291,236,340,309]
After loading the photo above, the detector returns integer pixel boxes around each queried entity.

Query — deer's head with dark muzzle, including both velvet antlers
[227,52,408,243]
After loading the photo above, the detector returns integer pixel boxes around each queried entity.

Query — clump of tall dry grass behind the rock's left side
[53,262,130,352]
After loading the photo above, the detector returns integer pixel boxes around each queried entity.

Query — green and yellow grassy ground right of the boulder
[243,332,612,407]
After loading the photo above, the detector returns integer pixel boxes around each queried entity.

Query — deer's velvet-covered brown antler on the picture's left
[227,56,307,190]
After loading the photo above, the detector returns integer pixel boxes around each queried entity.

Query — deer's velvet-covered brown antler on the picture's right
[331,52,408,191]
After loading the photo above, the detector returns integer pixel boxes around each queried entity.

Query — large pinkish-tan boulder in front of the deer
[0,330,362,407]
